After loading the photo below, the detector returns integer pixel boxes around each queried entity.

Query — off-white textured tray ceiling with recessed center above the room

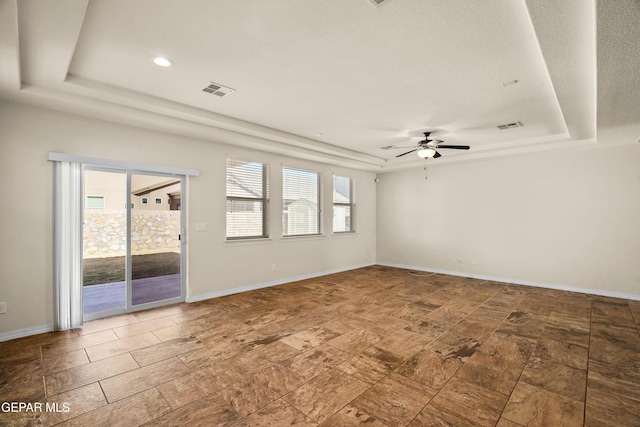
[0,0,640,171]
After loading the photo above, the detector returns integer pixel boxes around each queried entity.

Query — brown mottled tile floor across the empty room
[0,266,640,427]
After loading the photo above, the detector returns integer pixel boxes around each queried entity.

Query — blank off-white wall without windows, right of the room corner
[377,136,640,299]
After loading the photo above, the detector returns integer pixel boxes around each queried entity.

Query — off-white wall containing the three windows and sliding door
[0,101,376,337]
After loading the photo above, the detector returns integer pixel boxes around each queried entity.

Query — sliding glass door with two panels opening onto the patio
[83,167,184,320]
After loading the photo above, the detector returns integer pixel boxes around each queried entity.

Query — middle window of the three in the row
[282,167,322,236]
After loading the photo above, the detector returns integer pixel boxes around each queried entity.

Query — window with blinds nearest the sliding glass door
[227,158,269,240]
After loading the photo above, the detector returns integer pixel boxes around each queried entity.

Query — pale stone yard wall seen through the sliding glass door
[83,209,180,258]
